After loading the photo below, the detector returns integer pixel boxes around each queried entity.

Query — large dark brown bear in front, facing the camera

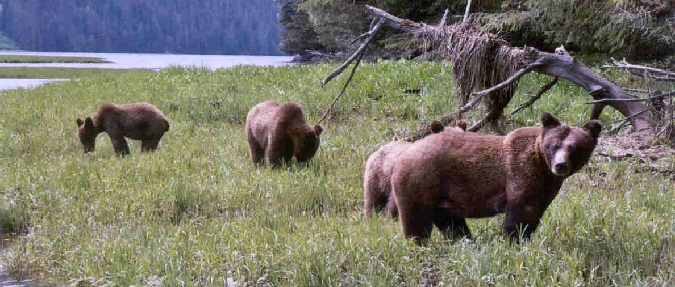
[391,113,601,244]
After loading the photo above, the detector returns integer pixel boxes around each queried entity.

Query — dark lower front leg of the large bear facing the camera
[504,203,542,242]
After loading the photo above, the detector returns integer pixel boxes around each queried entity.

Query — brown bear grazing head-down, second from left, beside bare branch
[246,101,322,167]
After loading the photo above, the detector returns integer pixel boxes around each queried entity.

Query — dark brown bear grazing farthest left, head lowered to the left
[77,103,169,155]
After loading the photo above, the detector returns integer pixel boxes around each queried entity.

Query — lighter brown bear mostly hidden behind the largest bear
[363,120,466,219]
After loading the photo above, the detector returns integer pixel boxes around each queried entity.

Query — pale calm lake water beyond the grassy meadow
[0,51,293,91]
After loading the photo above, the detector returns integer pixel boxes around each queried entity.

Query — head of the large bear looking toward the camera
[539,113,602,177]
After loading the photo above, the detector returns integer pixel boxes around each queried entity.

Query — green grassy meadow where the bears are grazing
[0,61,675,286]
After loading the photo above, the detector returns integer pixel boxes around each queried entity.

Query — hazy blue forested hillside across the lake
[0,0,281,55]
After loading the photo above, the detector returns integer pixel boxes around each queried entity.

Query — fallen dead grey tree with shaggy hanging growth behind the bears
[323,5,655,140]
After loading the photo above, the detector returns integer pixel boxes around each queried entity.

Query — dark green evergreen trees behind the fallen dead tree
[277,0,675,58]
